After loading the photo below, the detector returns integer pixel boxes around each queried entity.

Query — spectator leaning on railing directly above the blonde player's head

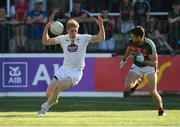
[69,0,88,34]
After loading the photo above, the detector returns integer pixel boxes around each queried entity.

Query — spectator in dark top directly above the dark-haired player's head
[134,0,151,28]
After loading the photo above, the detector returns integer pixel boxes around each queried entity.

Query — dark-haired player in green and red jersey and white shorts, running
[120,26,165,116]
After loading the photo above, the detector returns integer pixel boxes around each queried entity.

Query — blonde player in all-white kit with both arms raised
[38,16,105,115]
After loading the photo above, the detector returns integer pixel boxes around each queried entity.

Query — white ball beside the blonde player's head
[50,21,64,36]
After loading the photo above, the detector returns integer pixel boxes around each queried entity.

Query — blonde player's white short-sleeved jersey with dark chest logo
[55,34,92,70]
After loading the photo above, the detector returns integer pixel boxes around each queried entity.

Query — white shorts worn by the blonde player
[55,66,83,86]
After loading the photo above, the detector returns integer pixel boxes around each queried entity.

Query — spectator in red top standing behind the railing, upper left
[14,0,29,50]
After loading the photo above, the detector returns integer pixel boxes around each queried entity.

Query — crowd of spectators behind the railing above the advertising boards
[0,0,180,54]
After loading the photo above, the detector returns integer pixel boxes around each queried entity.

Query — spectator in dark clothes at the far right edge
[168,0,180,48]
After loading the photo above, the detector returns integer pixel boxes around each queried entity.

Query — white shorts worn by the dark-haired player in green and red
[130,64,156,75]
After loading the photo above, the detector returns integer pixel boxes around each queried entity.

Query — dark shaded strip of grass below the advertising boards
[0,95,180,112]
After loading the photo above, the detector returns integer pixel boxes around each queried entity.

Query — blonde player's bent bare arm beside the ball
[42,21,55,45]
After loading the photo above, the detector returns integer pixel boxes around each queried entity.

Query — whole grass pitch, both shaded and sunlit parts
[0,95,180,126]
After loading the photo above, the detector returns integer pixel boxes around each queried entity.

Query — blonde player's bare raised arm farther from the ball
[91,16,105,42]
